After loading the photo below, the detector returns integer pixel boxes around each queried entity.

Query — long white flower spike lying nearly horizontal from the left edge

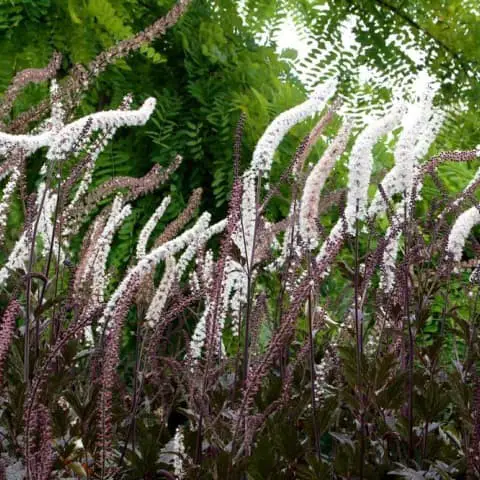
[0,98,156,160]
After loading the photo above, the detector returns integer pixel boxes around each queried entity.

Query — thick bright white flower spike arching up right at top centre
[250,80,337,176]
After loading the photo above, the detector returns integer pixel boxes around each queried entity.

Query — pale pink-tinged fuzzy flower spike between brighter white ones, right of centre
[299,126,350,249]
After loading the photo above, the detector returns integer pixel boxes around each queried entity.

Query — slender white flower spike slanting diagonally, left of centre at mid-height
[99,212,211,332]
